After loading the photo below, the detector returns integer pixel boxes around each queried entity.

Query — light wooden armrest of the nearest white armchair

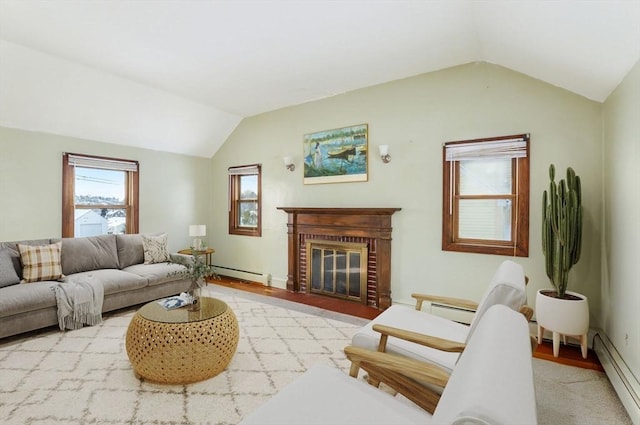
[344,346,449,413]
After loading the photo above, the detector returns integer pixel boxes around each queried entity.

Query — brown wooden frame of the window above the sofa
[62,152,140,238]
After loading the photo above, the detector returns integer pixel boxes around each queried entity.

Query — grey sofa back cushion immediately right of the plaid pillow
[61,235,118,275]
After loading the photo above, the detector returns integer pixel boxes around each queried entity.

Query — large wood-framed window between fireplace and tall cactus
[442,134,529,257]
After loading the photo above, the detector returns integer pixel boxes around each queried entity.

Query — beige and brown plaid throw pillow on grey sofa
[18,242,64,283]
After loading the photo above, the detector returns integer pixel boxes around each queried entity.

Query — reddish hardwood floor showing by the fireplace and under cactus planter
[209,276,604,372]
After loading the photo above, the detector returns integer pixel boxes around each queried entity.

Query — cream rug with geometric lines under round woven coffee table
[0,285,367,425]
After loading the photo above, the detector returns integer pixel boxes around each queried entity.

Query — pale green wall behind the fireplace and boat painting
[209,63,603,326]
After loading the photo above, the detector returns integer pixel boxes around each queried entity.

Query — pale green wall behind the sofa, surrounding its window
[0,127,210,250]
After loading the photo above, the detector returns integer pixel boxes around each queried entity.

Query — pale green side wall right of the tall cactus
[602,58,640,380]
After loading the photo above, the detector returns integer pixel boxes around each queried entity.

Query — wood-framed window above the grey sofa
[62,153,139,238]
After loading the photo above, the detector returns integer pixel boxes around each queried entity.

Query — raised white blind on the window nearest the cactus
[444,135,528,161]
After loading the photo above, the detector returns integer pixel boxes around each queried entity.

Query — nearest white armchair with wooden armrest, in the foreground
[241,305,537,425]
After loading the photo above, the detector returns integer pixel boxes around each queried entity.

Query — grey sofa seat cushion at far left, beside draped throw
[0,281,57,317]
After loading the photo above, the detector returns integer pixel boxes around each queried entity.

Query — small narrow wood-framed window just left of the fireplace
[229,164,262,236]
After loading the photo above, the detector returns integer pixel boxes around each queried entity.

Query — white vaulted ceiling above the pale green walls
[0,0,640,157]
